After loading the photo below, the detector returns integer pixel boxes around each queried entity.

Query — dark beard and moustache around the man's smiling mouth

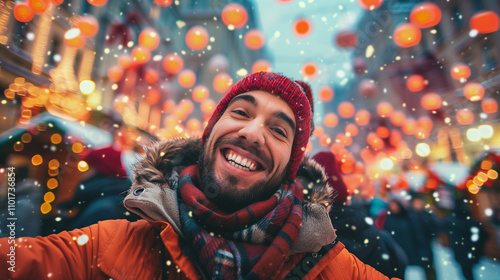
[199,138,288,213]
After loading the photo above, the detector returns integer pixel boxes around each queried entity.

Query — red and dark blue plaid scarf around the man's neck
[178,165,303,279]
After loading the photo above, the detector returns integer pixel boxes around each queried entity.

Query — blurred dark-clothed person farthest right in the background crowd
[441,201,488,280]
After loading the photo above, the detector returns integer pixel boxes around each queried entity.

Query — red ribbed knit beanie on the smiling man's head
[202,72,312,179]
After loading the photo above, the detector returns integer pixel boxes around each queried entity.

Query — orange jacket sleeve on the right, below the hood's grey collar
[304,242,398,280]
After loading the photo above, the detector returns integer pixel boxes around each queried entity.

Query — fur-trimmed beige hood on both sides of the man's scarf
[124,138,336,253]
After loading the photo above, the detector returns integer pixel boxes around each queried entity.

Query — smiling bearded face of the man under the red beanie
[200,90,296,211]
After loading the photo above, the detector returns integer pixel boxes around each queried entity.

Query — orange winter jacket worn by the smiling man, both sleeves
[0,220,398,280]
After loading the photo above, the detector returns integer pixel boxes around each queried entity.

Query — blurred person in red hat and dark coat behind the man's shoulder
[312,151,408,278]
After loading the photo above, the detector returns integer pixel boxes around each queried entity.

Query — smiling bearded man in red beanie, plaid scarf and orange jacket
[0,72,398,279]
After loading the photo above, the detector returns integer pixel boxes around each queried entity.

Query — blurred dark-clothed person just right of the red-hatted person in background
[375,193,435,279]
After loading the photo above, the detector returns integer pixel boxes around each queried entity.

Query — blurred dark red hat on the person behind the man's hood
[312,152,348,205]
